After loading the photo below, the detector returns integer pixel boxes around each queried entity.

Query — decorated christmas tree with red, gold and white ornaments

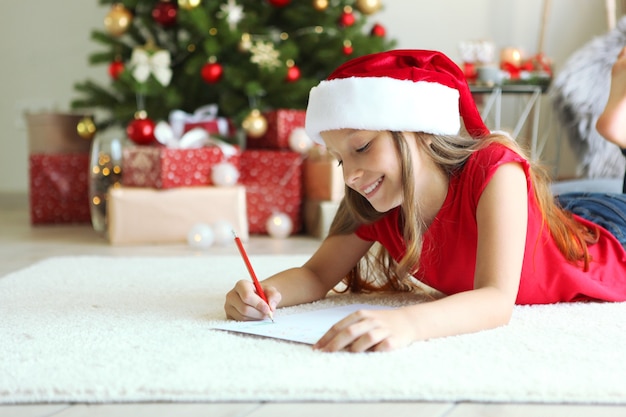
[72,0,394,139]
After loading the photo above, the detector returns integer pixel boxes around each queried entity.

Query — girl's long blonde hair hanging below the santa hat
[329,132,598,292]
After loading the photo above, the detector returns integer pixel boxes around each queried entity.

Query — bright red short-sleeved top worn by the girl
[356,144,626,304]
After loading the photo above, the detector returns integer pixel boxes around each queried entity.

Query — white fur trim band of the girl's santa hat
[305,77,461,144]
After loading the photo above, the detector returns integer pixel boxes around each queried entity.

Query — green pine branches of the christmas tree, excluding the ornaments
[71,0,395,133]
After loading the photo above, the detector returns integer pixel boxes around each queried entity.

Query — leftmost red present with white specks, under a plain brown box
[29,153,91,224]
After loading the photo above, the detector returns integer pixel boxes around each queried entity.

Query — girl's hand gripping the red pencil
[224,280,282,321]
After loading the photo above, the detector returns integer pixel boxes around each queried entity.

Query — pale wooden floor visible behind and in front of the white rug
[0,194,626,417]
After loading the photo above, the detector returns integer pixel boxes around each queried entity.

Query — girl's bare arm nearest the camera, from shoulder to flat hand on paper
[315,163,528,351]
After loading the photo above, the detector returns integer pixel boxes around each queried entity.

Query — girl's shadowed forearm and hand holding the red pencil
[224,234,372,320]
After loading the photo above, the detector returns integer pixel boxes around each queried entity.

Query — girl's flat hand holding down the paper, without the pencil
[313,309,416,352]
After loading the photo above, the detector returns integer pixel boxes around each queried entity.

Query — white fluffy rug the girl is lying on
[0,255,626,404]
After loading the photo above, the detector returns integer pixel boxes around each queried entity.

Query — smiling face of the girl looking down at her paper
[322,129,417,213]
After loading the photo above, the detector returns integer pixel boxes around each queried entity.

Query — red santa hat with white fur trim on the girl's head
[305,50,489,143]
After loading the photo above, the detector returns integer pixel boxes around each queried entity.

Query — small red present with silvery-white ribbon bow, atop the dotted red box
[169,104,237,138]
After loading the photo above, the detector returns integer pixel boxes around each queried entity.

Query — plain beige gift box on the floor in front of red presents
[107,186,248,245]
